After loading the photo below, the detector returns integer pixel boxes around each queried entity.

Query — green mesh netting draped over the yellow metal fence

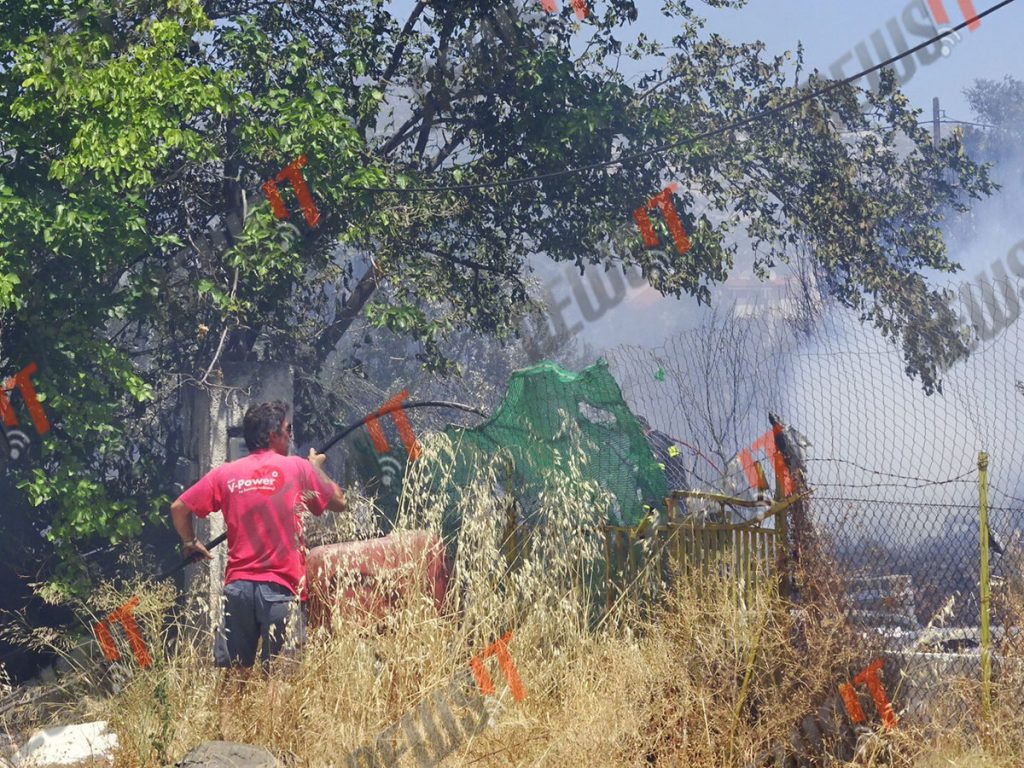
[445,359,666,529]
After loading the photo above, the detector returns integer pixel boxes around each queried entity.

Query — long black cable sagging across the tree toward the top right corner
[342,0,1014,193]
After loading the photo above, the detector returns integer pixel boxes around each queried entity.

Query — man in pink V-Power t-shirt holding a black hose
[171,400,345,669]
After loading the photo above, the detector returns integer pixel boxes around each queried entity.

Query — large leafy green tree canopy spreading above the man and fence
[0,0,989,585]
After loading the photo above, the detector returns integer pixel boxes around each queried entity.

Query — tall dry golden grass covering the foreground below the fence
[12,438,1024,768]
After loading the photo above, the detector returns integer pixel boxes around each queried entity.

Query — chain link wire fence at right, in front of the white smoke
[607,283,1024,716]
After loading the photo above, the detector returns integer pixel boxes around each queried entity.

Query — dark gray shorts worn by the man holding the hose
[213,580,306,669]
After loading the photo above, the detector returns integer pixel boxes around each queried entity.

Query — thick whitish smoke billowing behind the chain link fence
[593,109,1024,550]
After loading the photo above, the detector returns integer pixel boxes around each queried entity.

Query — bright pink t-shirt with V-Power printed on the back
[181,449,334,600]
